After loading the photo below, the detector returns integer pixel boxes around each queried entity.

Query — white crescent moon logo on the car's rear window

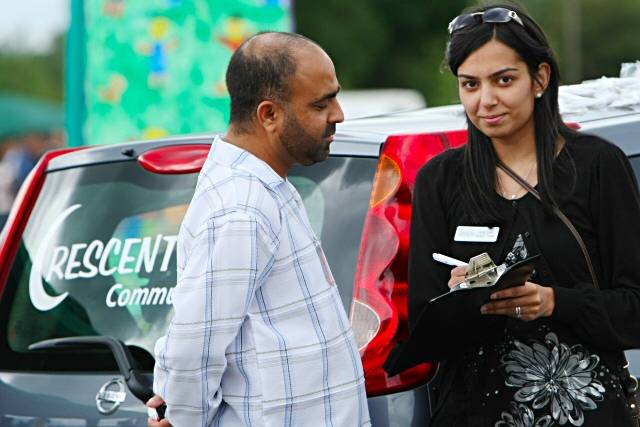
[29,204,82,311]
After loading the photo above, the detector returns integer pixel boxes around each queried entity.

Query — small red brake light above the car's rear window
[138,144,211,174]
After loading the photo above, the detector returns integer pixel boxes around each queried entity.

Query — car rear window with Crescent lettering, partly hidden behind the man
[0,157,376,369]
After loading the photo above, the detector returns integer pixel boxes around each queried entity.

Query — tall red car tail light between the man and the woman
[350,131,467,396]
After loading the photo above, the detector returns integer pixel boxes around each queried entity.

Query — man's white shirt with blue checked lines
[153,138,370,427]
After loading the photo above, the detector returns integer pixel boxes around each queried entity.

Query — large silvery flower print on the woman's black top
[496,332,605,426]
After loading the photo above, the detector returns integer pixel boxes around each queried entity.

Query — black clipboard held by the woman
[384,255,540,375]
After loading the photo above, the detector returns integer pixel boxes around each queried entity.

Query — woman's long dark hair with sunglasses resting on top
[445,2,574,221]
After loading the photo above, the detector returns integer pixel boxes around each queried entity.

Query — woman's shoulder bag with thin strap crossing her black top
[497,160,640,426]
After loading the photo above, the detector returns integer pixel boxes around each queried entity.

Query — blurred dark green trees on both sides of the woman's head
[295,0,640,105]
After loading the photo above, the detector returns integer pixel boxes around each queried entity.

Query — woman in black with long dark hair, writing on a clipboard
[409,4,640,426]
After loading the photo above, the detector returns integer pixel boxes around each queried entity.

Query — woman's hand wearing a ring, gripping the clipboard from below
[480,282,556,322]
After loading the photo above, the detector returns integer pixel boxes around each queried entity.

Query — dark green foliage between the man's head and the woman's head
[295,0,466,105]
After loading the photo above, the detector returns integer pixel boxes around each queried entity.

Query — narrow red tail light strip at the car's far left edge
[0,147,86,296]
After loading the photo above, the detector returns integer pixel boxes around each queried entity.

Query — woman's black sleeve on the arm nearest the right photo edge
[553,144,640,350]
